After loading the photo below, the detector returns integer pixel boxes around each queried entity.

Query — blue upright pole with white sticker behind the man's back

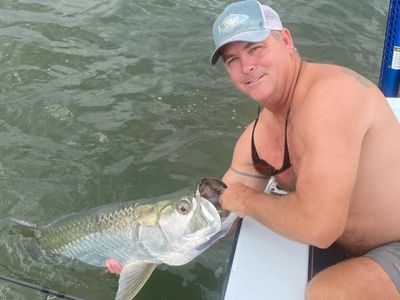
[379,0,400,97]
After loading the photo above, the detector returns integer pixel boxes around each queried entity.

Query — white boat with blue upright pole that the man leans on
[221,0,400,300]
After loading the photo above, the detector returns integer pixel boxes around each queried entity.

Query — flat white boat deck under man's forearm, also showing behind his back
[223,98,400,300]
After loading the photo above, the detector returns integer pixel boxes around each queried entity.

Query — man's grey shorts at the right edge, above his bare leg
[363,242,400,293]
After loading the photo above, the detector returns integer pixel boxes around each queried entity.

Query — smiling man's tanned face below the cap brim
[221,34,288,103]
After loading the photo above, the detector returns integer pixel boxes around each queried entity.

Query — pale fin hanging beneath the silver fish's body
[115,261,157,300]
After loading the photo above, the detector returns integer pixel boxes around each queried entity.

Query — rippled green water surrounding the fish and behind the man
[0,0,389,300]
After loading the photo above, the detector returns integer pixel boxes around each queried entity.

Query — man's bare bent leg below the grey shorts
[306,257,400,300]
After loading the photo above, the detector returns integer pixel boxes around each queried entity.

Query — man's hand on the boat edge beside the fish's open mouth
[219,183,257,218]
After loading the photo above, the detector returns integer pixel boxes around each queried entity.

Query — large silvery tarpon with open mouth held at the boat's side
[12,179,236,300]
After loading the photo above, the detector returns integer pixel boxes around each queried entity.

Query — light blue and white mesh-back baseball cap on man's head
[210,0,283,65]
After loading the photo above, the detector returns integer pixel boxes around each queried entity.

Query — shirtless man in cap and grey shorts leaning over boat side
[211,0,400,300]
